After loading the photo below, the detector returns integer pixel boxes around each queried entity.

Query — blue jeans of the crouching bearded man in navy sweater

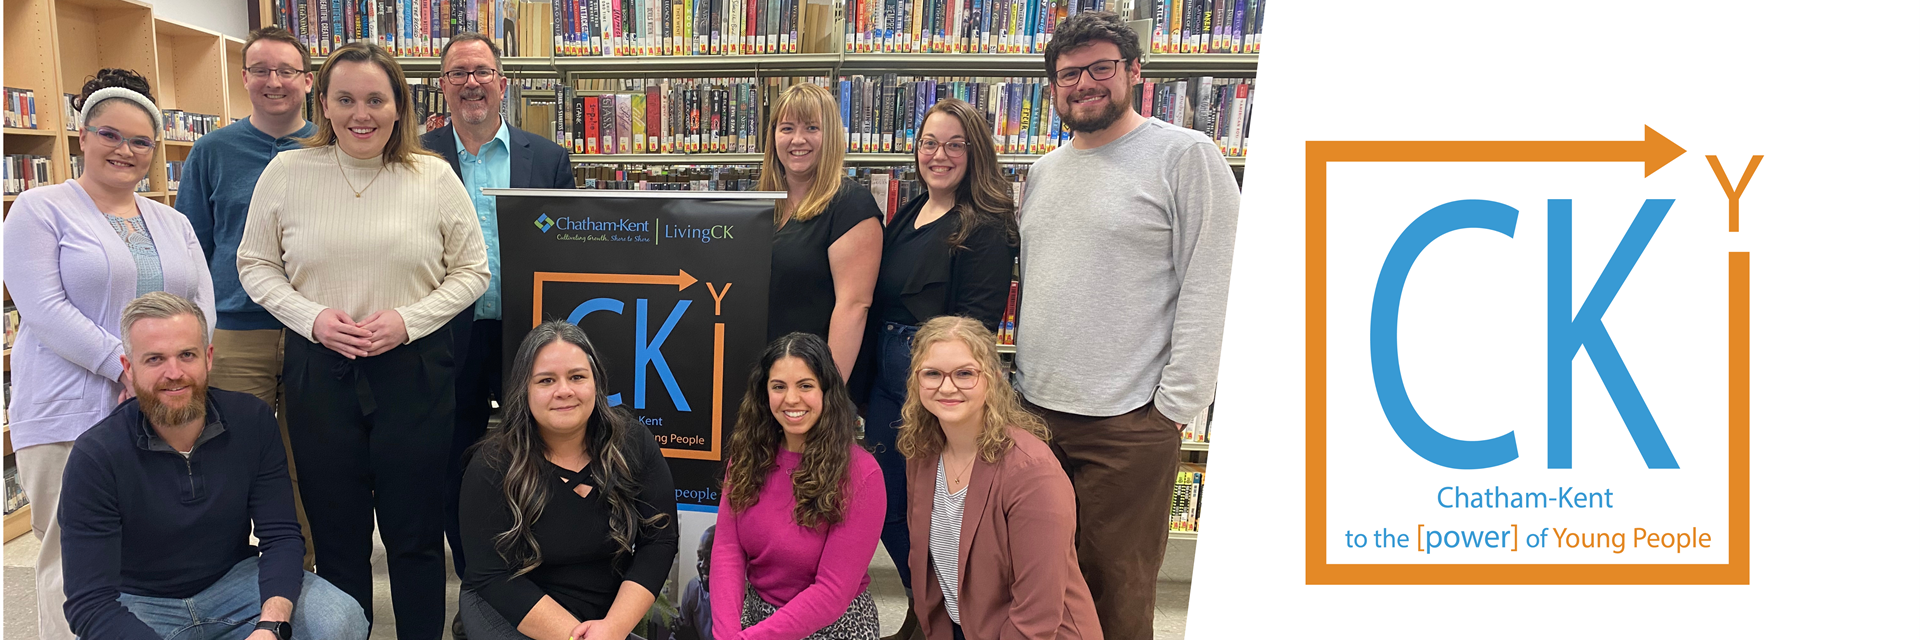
[119,557,367,640]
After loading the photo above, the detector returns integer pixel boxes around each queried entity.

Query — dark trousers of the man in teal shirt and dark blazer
[445,308,503,577]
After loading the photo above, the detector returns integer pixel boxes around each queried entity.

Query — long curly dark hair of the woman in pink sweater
[726,332,860,529]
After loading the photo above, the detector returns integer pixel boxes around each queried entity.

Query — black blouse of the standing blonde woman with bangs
[766,179,883,340]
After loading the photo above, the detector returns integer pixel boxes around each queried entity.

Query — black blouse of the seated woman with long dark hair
[461,423,680,625]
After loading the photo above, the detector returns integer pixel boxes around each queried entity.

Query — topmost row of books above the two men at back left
[275,0,804,58]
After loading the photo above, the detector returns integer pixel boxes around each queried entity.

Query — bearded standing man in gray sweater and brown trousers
[1016,12,1240,640]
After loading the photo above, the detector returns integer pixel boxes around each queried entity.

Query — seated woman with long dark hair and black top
[461,321,680,640]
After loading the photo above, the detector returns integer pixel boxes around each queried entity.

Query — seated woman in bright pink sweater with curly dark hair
[710,332,887,640]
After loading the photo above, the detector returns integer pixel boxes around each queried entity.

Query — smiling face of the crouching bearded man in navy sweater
[125,313,213,427]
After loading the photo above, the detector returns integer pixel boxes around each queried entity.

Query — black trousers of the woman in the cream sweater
[284,329,453,640]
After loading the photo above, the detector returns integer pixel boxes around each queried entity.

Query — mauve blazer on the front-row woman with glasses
[906,422,1100,640]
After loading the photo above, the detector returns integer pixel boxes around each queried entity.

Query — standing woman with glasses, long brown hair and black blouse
[862,98,1020,638]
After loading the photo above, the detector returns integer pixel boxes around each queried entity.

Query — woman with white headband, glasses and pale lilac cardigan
[6,69,213,640]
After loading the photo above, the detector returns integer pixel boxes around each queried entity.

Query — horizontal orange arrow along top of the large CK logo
[1308,127,1686,175]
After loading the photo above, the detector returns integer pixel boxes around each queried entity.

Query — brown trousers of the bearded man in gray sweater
[1025,404,1181,640]
